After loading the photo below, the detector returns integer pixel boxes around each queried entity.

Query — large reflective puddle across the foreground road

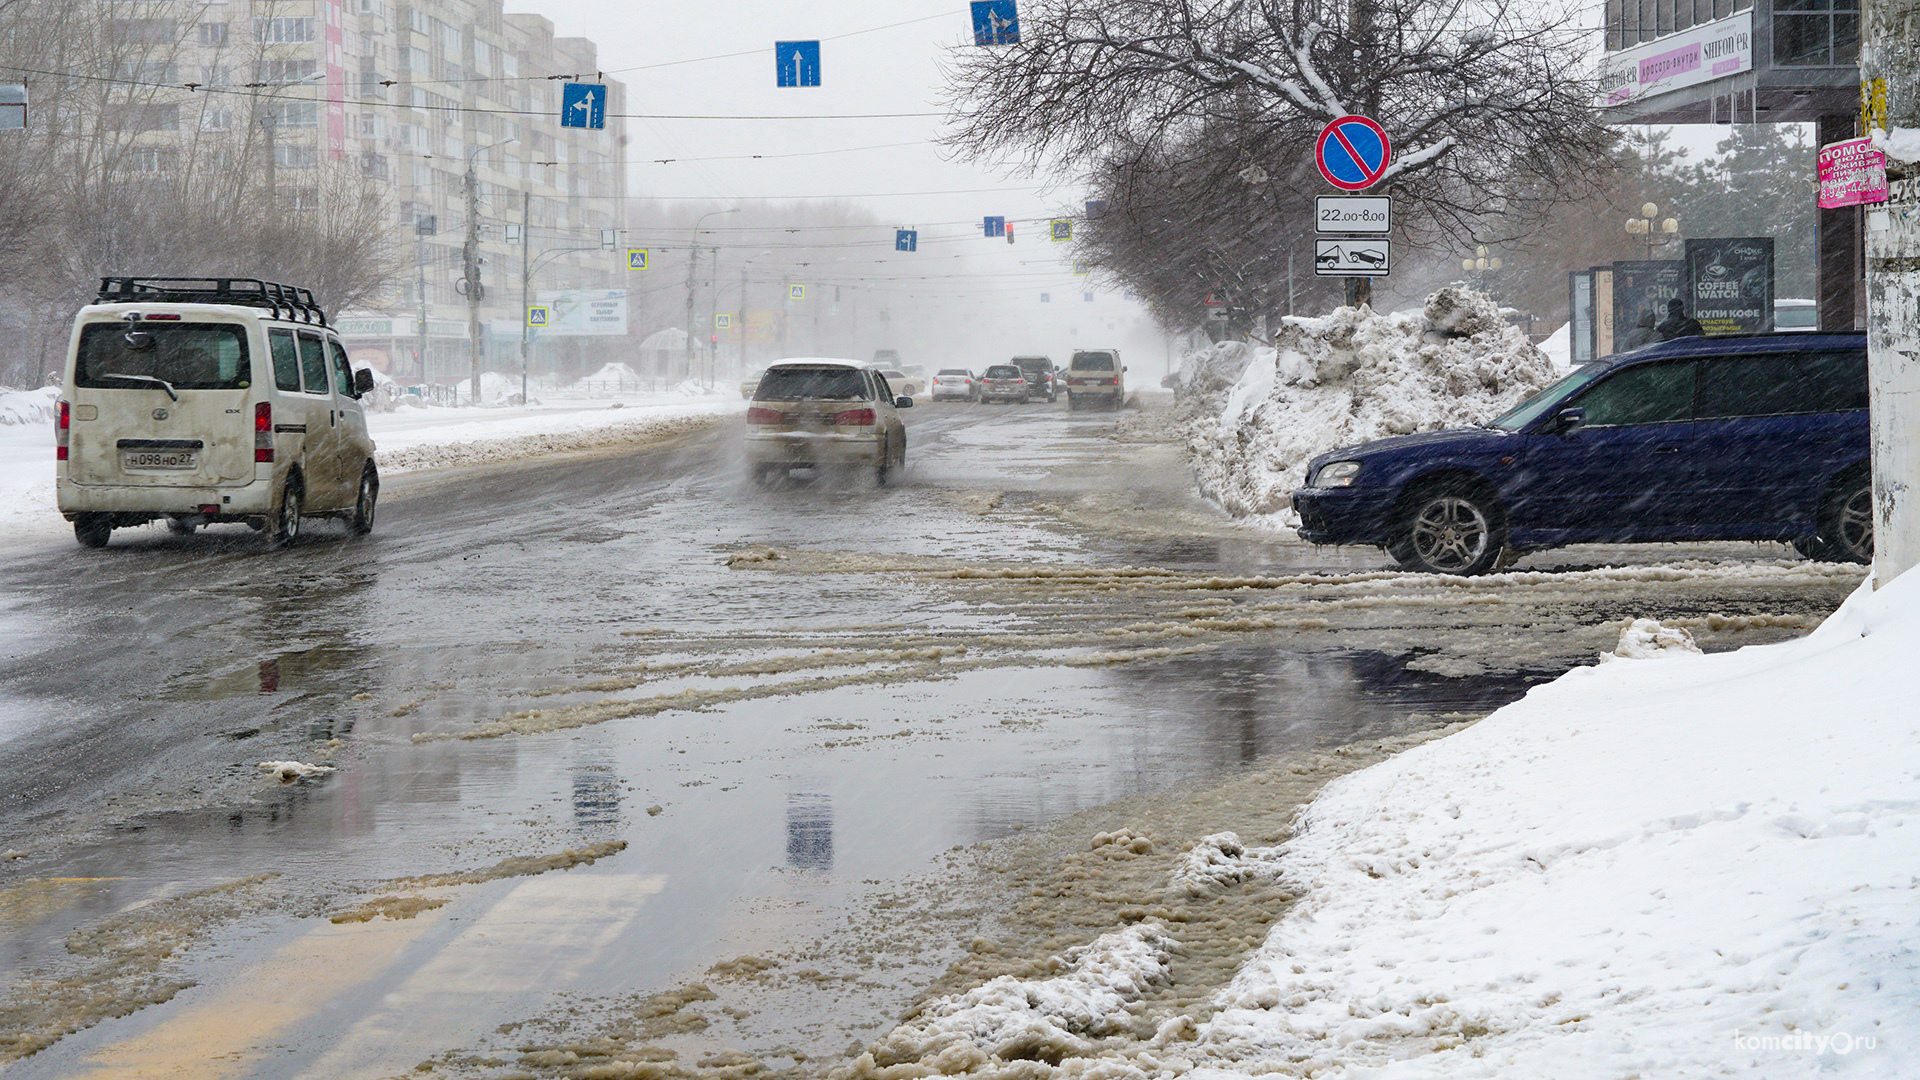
[0,644,1530,1076]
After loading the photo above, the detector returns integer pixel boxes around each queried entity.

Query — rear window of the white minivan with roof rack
[73,321,252,390]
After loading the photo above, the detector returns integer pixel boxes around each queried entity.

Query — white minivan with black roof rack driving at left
[54,277,380,548]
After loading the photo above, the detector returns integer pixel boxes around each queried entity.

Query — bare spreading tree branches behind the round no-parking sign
[948,0,1611,272]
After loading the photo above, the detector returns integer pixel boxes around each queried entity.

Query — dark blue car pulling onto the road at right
[1294,332,1874,575]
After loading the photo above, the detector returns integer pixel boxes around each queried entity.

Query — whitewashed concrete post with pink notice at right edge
[1860,0,1920,588]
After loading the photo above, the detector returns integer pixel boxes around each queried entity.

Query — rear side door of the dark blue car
[1693,350,1868,538]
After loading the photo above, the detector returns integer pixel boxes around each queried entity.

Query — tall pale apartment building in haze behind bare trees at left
[169,0,626,382]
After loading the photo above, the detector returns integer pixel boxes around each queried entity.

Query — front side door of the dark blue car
[1517,357,1695,540]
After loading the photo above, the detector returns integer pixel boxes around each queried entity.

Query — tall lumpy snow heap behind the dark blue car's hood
[1183,286,1557,525]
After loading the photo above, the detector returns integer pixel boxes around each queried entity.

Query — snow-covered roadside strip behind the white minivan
[0,386,745,538]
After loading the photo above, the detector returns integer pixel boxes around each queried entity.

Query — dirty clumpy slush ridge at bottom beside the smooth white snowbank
[848,922,1177,1060]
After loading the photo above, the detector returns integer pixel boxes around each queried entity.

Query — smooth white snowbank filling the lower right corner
[1192,573,1920,1080]
